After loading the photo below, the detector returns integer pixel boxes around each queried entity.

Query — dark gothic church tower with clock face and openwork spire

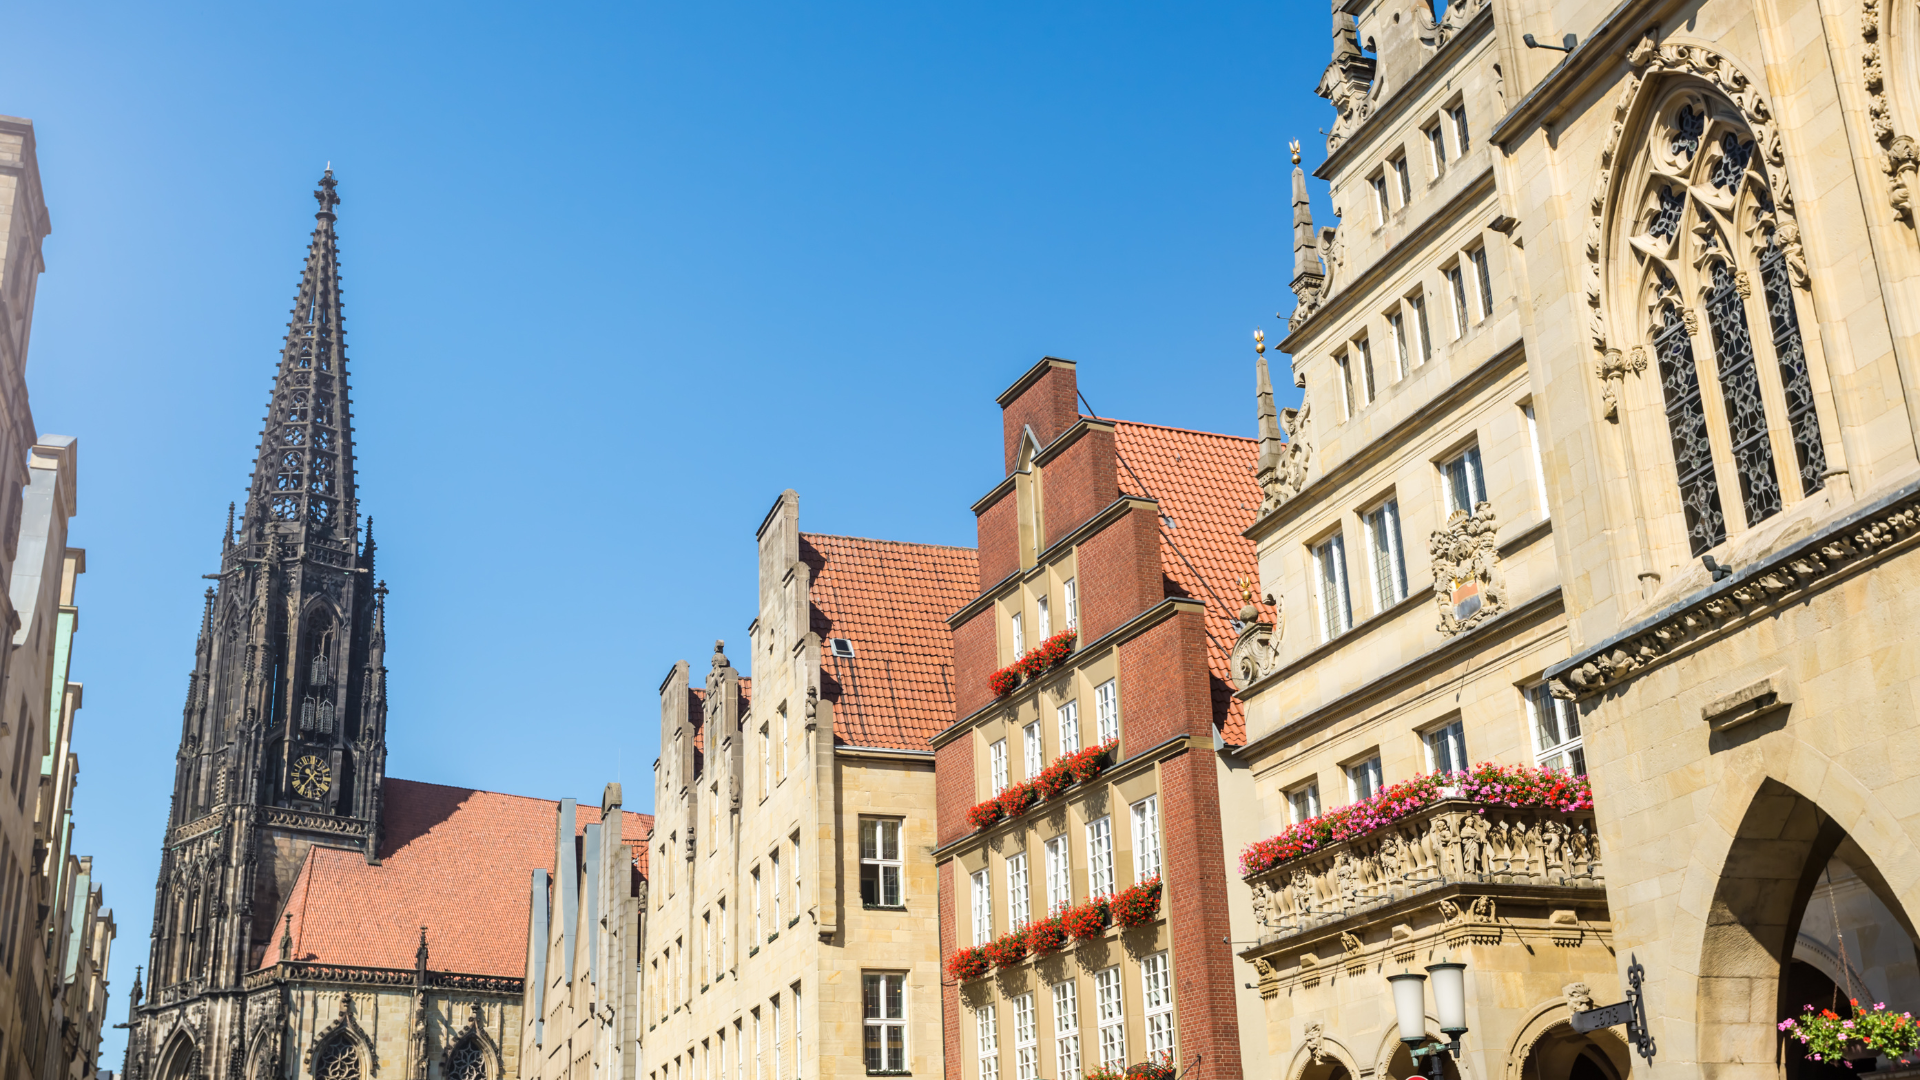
[136,169,386,1006]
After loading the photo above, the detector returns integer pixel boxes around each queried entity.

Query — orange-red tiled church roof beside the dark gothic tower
[265,778,653,978]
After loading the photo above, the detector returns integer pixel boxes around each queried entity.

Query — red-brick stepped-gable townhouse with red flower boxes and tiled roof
[933,357,1260,1080]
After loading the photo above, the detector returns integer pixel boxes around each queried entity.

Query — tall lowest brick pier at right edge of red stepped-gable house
[1152,749,1252,1080]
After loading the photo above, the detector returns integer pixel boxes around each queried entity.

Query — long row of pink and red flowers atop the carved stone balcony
[1240,761,1594,878]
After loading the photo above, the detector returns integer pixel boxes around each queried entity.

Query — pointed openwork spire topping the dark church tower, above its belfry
[242,169,353,548]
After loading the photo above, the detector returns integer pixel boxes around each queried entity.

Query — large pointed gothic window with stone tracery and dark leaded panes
[1615,85,1826,555]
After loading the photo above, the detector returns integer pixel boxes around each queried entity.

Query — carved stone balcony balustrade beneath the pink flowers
[1246,799,1605,944]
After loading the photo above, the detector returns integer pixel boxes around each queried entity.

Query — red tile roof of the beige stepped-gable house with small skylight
[801,532,979,749]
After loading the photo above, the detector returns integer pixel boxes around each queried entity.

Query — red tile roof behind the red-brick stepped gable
[1105,421,1261,746]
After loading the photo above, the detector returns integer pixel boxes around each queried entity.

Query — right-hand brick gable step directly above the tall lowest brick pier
[1119,609,1213,749]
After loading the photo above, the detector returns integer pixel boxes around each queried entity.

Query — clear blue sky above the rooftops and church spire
[0,2,1331,1068]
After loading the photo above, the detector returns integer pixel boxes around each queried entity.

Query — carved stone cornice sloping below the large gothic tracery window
[1548,480,1920,701]
